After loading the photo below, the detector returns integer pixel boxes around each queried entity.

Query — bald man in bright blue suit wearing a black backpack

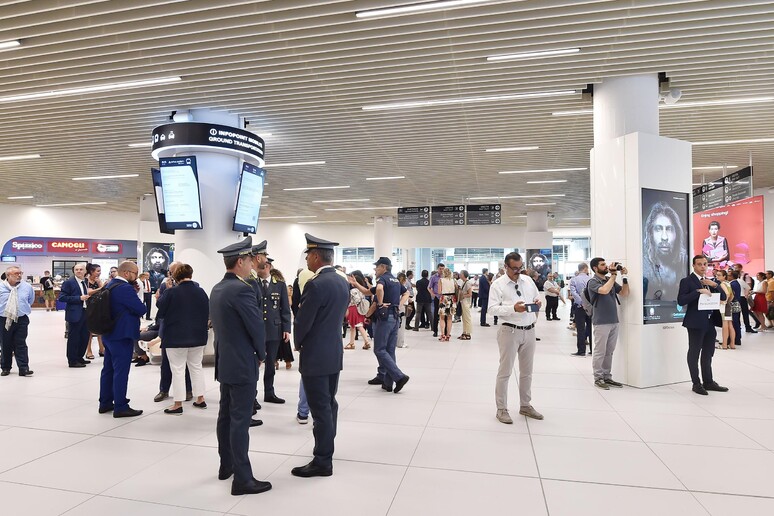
[98,261,145,417]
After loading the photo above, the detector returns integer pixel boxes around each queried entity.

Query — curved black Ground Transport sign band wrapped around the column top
[151,122,264,166]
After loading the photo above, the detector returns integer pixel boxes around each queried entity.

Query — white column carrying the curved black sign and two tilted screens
[155,110,242,294]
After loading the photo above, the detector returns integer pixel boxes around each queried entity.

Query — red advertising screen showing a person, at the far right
[693,195,766,277]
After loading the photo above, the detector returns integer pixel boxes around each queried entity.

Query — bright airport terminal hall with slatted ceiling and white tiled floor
[0,0,774,516]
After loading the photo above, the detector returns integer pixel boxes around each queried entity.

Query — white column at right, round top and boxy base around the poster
[589,74,691,387]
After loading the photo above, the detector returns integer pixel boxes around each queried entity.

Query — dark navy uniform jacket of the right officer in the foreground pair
[293,267,349,376]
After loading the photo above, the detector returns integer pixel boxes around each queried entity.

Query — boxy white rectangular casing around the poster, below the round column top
[591,133,692,387]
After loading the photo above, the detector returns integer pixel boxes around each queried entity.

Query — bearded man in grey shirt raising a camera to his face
[587,258,629,391]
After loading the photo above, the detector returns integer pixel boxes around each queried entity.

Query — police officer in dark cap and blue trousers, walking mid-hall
[350,256,409,393]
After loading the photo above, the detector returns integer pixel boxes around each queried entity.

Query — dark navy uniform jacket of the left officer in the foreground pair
[209,272,266,384]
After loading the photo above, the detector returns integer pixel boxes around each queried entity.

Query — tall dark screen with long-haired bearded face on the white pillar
[642,188,690,324]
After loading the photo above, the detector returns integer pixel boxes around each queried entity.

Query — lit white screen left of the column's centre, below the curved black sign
[159,156,202,230]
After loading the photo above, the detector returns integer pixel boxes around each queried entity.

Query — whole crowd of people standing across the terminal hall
[0,242,774,495]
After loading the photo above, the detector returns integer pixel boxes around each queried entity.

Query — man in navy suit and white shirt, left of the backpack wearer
[59,263,91,367]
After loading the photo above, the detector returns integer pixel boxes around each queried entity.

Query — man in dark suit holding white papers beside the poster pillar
[677,254,728,396]
